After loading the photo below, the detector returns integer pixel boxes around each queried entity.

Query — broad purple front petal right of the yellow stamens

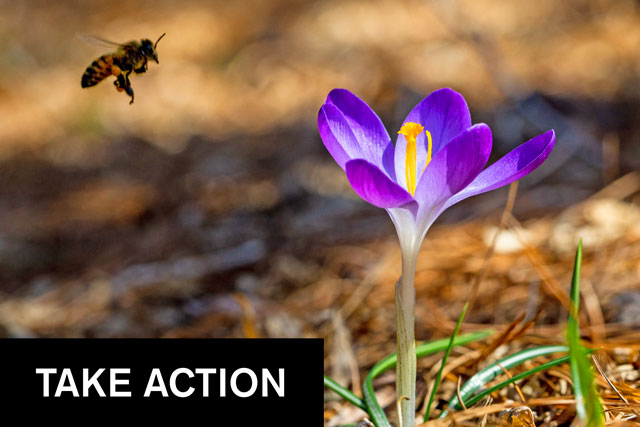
[415,123,492,210]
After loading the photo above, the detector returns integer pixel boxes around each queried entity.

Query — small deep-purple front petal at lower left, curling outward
[345,159,413,209]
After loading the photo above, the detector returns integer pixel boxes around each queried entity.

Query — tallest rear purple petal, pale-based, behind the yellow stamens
[395,88,471,187]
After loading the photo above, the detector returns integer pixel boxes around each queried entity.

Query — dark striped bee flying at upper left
[79,33,166,105]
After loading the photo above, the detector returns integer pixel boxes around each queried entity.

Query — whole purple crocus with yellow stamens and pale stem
[318,88,555,427]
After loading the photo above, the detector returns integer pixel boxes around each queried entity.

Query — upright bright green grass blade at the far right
[567,239,604,427]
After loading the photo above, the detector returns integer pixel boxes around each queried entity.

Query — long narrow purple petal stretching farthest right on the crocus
[445,129,556,208]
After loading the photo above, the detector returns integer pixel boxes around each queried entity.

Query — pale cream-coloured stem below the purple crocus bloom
[396,250,418,427]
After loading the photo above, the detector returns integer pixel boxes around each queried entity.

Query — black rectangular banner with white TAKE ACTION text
[0,339,324,426]
